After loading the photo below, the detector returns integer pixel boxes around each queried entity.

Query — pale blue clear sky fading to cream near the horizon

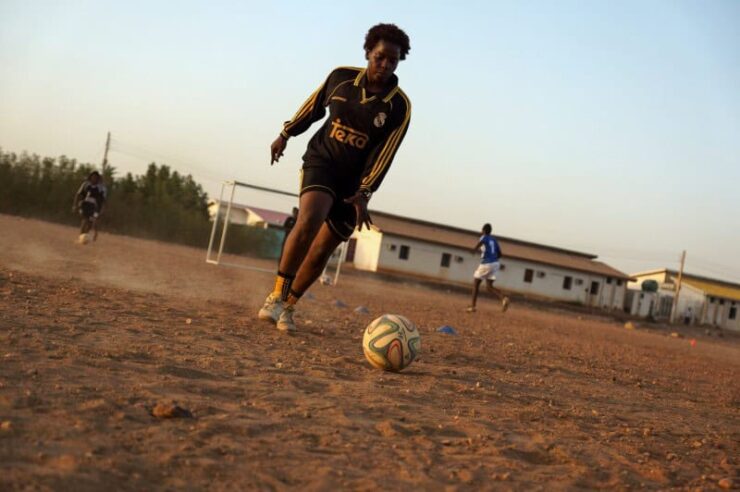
[0,0,740,281]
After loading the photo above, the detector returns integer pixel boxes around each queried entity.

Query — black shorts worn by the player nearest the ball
[300,164,360,241]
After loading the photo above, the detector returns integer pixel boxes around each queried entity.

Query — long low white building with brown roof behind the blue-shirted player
[347,211,629,310]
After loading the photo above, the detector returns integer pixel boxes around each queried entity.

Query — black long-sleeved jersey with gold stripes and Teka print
[281,67,411,191]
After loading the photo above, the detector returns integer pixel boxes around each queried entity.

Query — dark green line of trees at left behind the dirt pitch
[0,149,281,257]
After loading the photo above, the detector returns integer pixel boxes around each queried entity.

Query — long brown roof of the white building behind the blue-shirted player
[371,211,630,280]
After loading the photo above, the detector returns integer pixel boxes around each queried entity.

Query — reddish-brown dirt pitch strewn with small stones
[0,215,740,491]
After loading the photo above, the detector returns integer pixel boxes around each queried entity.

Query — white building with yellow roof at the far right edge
[629,268,740,331]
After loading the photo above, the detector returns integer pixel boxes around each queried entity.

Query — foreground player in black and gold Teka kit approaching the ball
[259,24,411,331]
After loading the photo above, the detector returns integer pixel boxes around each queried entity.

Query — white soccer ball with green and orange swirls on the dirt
[362,314,421,372]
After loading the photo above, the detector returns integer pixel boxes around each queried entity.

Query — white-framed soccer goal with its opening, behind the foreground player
[206,181,347,285]
